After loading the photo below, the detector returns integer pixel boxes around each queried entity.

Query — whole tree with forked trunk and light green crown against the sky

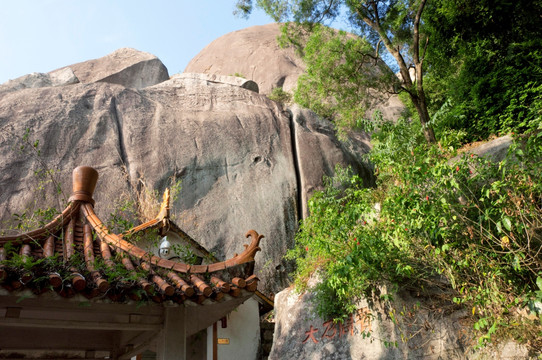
[242,0,442,143]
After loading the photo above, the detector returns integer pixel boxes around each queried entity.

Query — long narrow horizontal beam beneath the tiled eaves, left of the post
[0,318,162,331]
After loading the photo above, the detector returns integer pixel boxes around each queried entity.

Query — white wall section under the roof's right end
[207,298,260,360]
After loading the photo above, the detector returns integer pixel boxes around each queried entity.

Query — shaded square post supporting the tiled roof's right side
[156,306,186,360]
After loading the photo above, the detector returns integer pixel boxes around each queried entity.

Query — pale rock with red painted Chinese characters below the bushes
[269,289,529,360]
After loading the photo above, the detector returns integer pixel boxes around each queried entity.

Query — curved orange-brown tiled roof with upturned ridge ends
[0,166,263,304]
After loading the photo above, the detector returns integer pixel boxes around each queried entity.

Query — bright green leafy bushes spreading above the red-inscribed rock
[288,121,542,344]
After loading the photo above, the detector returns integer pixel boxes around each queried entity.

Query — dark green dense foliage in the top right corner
[425,0,542,140]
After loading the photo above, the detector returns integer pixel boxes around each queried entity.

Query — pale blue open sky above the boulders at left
[0,0,273,83]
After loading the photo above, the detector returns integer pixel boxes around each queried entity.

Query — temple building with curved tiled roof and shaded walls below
[0,166,263,360]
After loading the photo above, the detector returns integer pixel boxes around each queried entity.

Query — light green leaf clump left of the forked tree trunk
[294,25,396,134]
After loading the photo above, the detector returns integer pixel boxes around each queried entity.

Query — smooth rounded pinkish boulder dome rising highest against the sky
[184,23,305,94]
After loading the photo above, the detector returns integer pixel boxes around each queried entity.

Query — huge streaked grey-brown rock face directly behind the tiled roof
[0,48,371,293]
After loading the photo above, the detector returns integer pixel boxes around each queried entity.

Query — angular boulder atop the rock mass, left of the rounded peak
[58,48,169,89]
